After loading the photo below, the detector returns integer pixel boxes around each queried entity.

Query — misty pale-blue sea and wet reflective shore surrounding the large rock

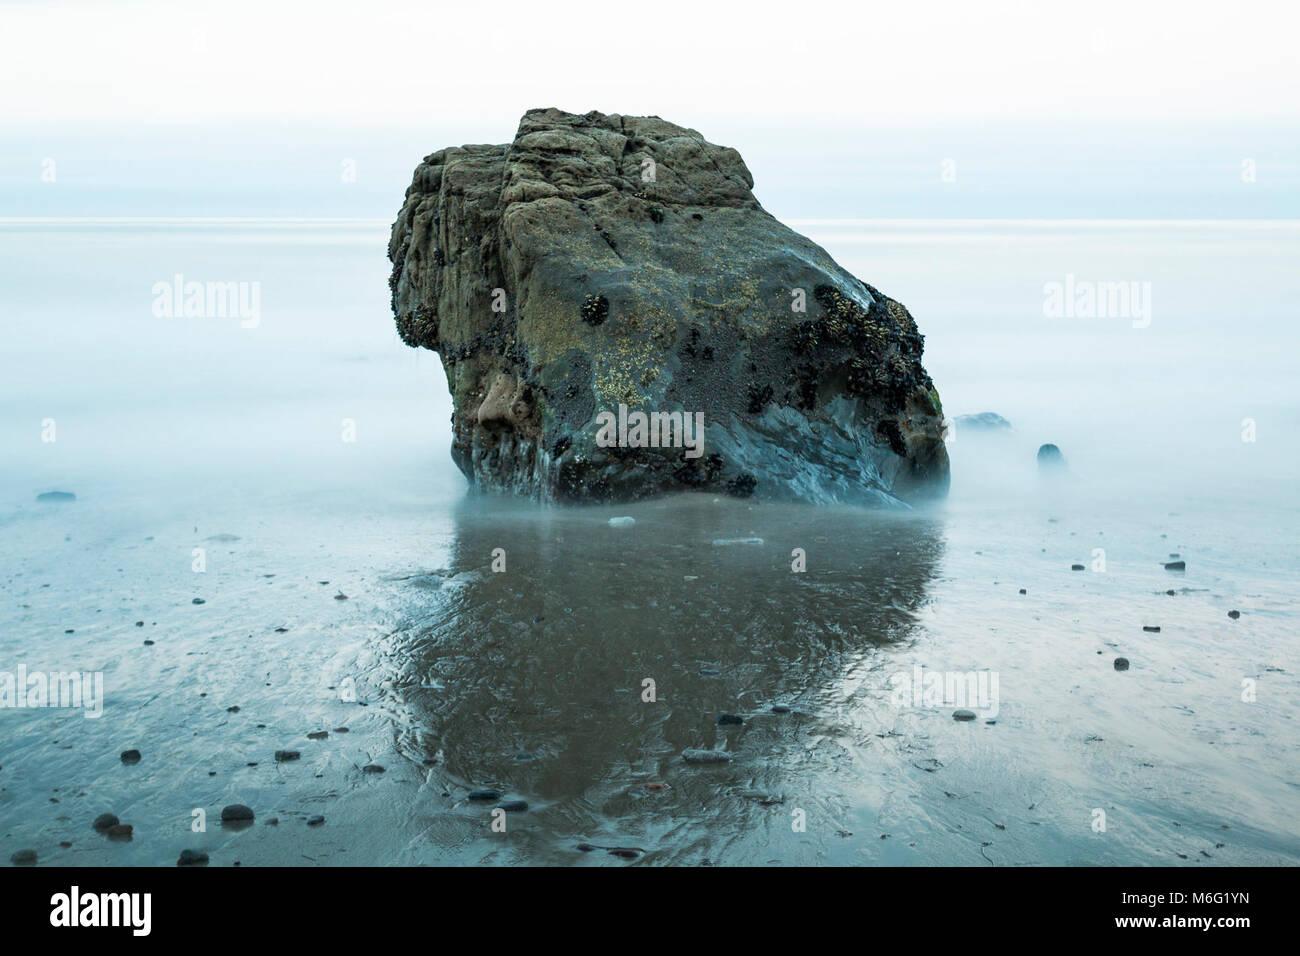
[0,220,1300,866]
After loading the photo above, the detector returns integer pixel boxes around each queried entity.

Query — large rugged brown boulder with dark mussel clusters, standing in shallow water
[389,109,948,503]
